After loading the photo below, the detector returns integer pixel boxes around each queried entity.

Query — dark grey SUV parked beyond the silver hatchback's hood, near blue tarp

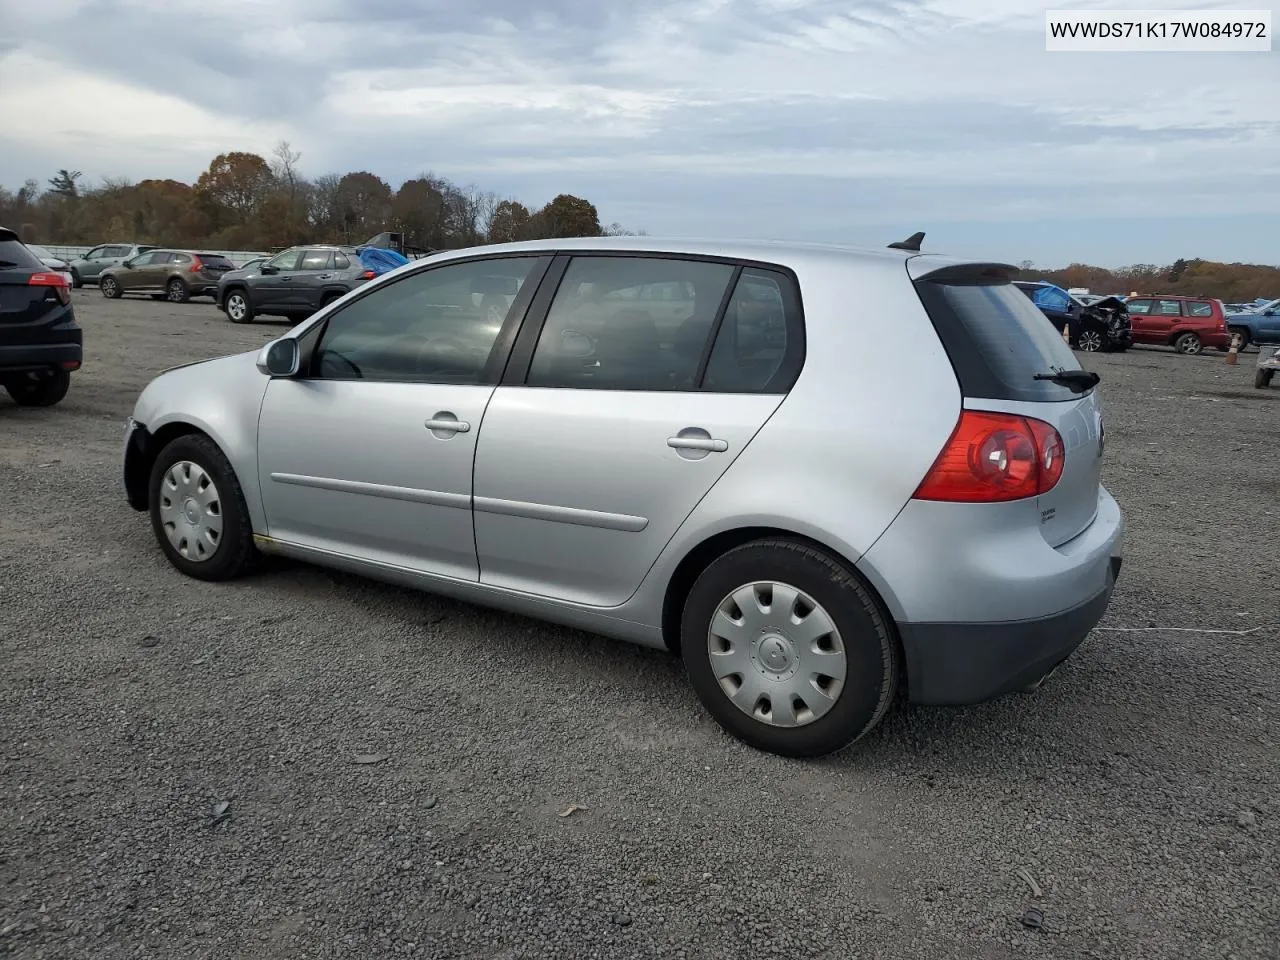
[215,244,376,324]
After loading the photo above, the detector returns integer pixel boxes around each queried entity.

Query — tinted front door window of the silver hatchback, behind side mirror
[312,257,538,383]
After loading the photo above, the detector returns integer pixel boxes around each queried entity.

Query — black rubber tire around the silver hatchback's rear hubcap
[680,539,900,758]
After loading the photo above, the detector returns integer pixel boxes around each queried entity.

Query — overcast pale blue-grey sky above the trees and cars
[0,0,1280,265]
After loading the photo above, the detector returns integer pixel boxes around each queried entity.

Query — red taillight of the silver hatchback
[915,410,1066,503]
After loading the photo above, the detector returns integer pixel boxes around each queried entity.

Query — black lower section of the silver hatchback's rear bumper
[899,557,1123,705]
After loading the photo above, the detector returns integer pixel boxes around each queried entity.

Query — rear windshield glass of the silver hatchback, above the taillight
[916,279,1082,402]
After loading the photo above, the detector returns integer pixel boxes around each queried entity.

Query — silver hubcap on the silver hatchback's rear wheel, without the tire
[707,581,849,727]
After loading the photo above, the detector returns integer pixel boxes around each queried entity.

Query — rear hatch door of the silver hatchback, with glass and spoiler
[909,257,1103,547]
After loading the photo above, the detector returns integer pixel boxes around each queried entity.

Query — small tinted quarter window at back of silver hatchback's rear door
[703,268,804,393]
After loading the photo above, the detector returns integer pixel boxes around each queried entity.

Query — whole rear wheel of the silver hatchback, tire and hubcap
[680,540,899,756]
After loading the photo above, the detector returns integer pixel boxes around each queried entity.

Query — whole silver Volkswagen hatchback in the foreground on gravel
[124,237,1123,756]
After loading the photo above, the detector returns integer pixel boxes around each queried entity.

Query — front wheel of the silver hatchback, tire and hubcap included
[150,434,259,580]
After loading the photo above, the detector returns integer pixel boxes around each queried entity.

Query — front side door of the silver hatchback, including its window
[257,256,550,581]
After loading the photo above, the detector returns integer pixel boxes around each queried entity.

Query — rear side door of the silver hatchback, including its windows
[475,255,803,607]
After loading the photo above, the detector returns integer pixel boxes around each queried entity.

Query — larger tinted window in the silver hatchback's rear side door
[527,257,733,390]
